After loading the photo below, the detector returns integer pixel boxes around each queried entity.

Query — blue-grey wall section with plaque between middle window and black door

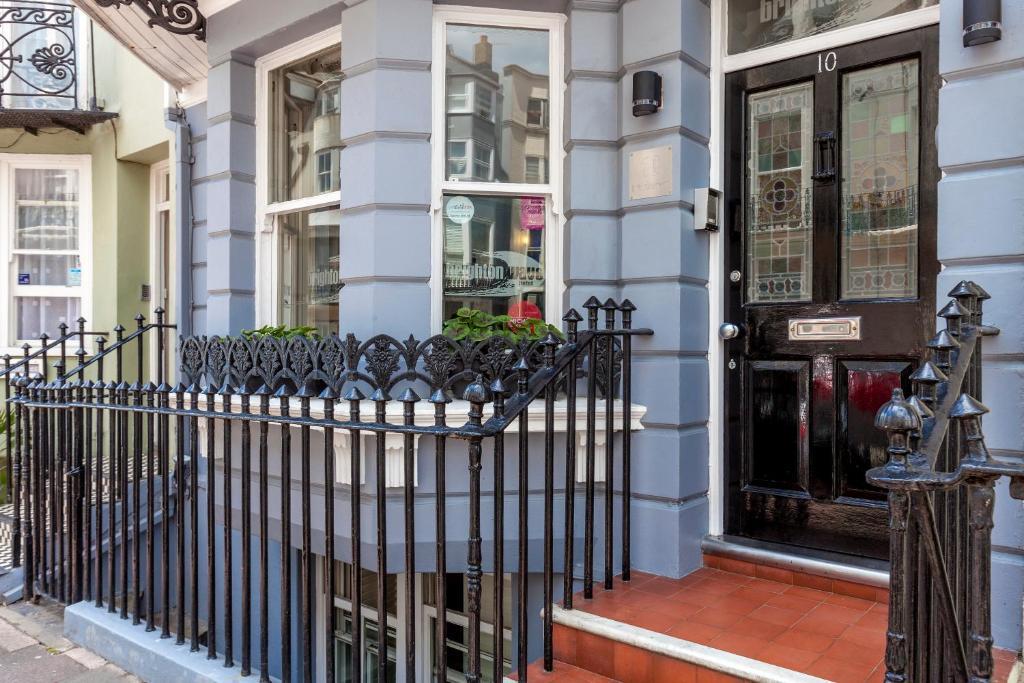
[563,0,711,577]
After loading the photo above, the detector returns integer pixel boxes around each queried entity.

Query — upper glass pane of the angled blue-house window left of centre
[267,47,341,202]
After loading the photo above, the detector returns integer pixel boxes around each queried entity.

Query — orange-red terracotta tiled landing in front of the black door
[566,567,1013,683]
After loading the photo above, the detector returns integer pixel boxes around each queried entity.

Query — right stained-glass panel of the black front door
[842,59,920,299]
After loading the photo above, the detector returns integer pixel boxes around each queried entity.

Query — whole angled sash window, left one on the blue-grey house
[257,28,341,335]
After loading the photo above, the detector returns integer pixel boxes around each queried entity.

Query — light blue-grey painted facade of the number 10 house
[169,0,1024,667]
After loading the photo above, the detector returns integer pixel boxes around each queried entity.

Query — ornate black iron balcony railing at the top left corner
[0,0,79,110]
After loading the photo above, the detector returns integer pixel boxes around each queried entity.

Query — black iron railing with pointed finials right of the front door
[868,282,1024,682]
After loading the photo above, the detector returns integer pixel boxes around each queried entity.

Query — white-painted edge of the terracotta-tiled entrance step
[551,605,828,683]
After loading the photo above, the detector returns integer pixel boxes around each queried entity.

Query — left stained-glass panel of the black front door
[745,83,814,303]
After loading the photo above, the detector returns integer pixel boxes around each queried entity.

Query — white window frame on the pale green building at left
[0,154,93,356]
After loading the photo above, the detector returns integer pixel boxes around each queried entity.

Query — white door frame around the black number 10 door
[708,5,939,536]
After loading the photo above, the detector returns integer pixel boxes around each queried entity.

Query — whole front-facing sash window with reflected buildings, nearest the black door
[432,9,563,328]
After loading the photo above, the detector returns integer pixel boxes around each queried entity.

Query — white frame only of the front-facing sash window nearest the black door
[430,6,565,333]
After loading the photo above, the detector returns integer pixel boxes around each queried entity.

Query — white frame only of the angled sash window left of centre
[256,24,341,328]
